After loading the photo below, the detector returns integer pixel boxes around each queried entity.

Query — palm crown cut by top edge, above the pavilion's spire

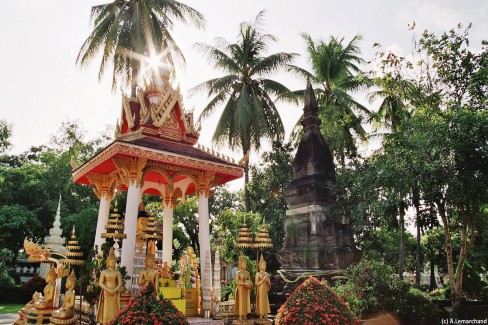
[77,0,204,92]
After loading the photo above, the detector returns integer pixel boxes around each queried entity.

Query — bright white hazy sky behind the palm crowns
[0,0,488,159]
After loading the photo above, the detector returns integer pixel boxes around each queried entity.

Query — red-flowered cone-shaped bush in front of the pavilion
[110,285,188,325]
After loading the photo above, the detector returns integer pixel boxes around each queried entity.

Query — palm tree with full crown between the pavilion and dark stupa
[193,11,296,211]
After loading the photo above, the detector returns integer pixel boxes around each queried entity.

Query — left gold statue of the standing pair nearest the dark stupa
[235,255,252,320]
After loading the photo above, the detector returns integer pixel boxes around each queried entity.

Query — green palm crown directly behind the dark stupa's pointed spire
[289,34,370,167]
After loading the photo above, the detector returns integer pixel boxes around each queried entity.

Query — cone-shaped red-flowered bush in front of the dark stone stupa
[275,277,359,325]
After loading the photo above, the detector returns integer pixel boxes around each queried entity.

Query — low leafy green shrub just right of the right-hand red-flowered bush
[334,260,440,324]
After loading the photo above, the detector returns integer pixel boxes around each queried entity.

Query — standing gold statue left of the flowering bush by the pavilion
[97,247,122,325]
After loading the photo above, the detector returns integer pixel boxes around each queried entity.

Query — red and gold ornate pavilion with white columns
[72,70,243,292]
